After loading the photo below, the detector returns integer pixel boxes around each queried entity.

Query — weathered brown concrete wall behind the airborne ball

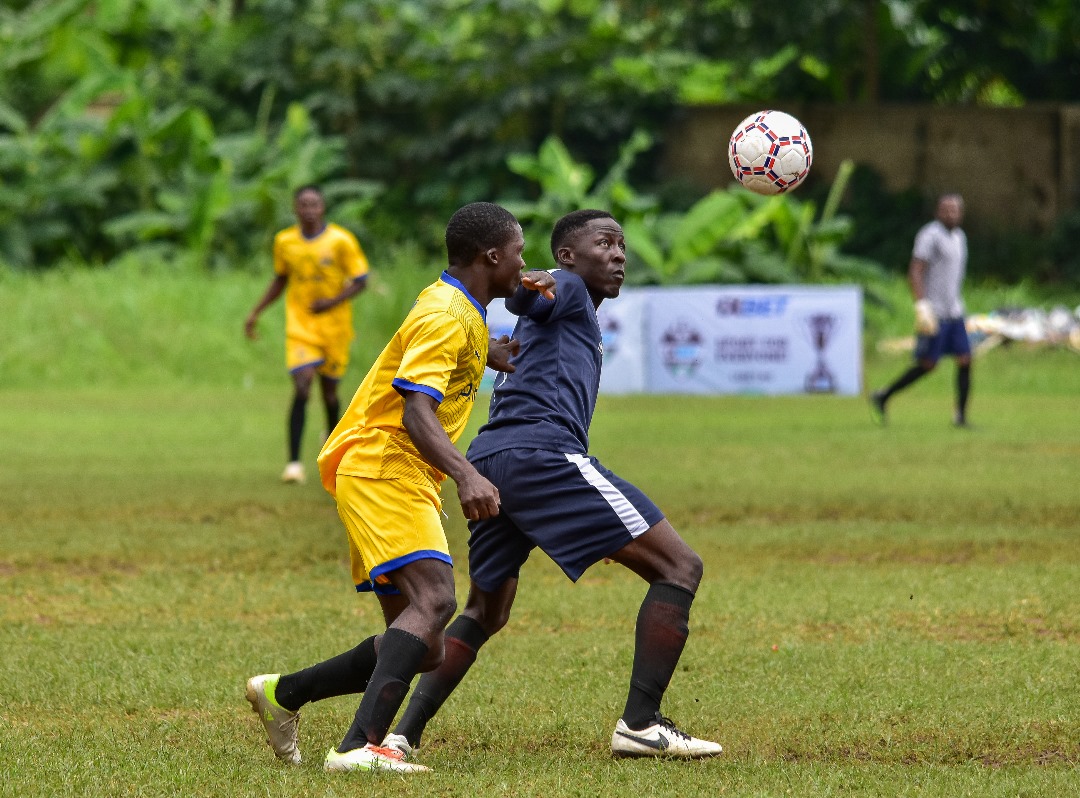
[663,103,1080,233]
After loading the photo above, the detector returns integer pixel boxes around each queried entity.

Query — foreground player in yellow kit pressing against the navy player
[247,202,555,773]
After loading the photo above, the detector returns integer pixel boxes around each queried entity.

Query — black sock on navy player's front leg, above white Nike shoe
[622,582,693,729]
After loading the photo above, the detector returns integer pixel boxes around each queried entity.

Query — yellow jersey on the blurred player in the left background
[273,224,367,346]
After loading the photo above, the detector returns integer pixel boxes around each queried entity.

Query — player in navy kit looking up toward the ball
[383,209,721,758]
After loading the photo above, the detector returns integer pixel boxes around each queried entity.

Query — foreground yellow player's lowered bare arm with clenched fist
[402,391,499,520]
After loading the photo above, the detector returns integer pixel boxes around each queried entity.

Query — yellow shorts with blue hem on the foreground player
[337,474,454,595]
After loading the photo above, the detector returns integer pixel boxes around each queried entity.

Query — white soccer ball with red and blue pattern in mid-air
[728,111,813,194]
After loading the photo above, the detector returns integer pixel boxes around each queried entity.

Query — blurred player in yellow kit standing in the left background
[244,186,367,483]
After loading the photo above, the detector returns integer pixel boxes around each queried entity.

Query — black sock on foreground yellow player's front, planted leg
[337,627,428,754]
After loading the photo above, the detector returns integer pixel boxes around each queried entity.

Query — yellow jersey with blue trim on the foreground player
[319,271,489,495]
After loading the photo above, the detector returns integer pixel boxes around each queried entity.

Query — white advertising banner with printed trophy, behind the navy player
[482,285,863,395]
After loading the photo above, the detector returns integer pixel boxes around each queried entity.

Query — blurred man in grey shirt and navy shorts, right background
[870,194,971,427]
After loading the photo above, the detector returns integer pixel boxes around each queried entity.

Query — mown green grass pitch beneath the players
[0,269,1080,797]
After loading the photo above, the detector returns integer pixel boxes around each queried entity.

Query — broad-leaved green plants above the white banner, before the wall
[503,132,883,285]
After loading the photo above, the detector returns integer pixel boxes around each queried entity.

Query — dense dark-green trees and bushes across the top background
[0,0,1080,273]
